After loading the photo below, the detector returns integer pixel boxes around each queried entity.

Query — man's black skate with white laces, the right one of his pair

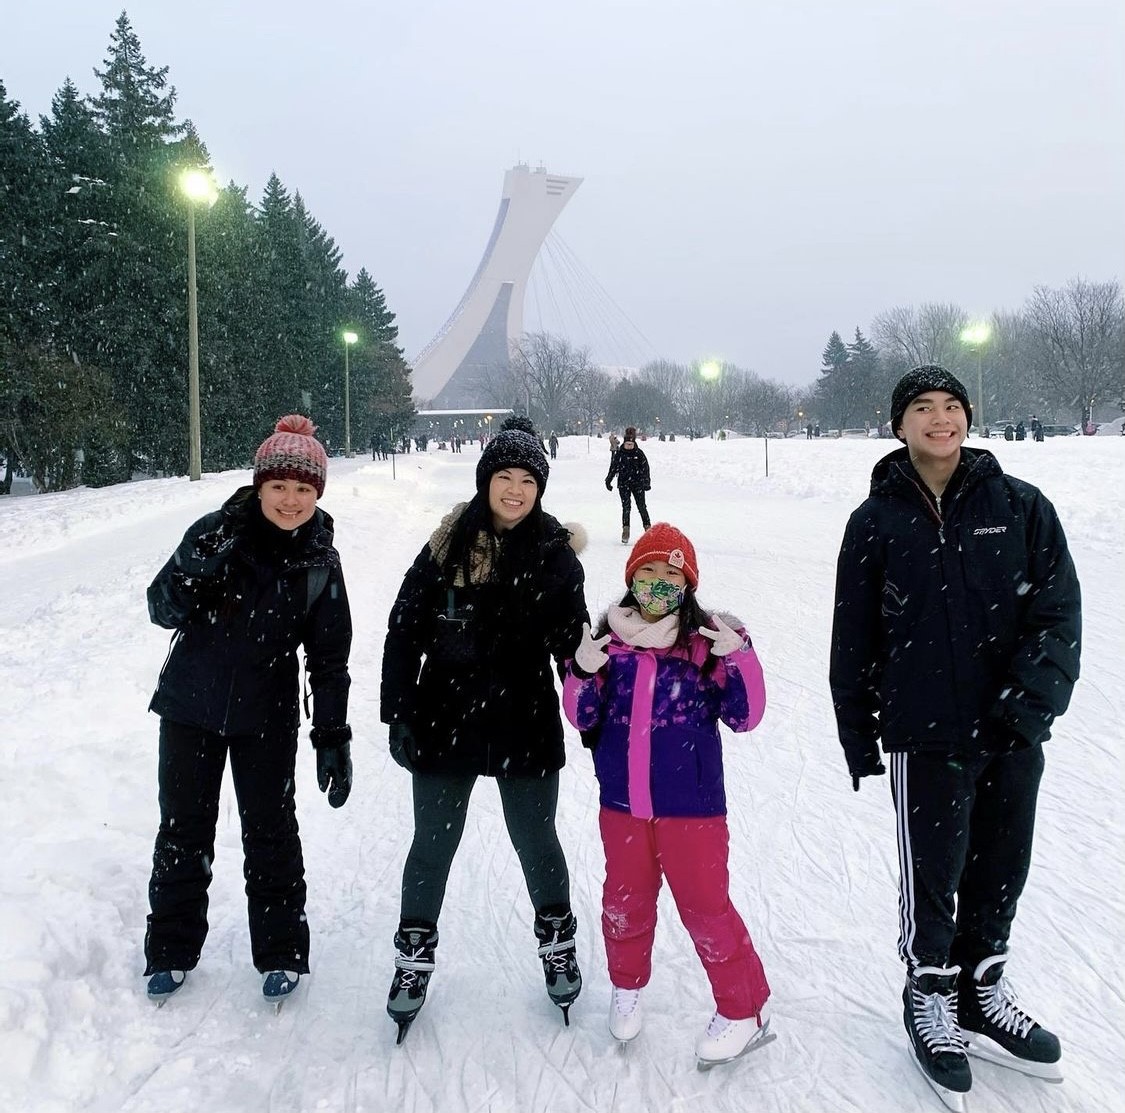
[961,954,1062,1083]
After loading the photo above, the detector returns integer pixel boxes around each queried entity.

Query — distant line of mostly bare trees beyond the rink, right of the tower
[445,278,1125,437]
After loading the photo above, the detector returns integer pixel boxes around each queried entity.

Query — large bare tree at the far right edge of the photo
[1024,278,1125,422]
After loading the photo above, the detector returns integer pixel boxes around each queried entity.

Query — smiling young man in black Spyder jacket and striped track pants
[830,366,1081,1110]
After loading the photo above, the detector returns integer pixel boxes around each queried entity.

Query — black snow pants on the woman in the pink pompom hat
[144,719,308,975]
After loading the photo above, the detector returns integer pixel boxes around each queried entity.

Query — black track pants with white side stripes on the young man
[890,746,1043,970]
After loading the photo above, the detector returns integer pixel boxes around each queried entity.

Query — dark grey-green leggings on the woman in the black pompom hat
[402,772,570,924]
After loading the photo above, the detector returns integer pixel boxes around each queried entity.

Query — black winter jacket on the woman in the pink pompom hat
[149,486,352,738]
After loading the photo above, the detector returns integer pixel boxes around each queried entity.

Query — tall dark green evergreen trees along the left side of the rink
[0,12,414,492]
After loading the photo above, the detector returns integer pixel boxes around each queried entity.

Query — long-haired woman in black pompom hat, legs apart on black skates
[381,427,588,1041]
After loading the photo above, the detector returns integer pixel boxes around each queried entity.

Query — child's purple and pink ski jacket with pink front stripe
[563,634,766,819]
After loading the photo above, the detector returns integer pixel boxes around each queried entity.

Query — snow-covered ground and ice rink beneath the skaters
[0,438,1125,1113]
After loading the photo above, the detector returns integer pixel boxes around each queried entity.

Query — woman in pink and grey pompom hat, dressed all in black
[145,415,351,999]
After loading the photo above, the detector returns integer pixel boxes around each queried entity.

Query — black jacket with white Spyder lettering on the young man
[830,448,1081,772]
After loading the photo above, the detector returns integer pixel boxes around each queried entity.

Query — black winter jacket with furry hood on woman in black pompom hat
[380,504,588,777]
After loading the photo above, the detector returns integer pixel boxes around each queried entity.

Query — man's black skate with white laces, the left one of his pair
[902,967,973,1113]
